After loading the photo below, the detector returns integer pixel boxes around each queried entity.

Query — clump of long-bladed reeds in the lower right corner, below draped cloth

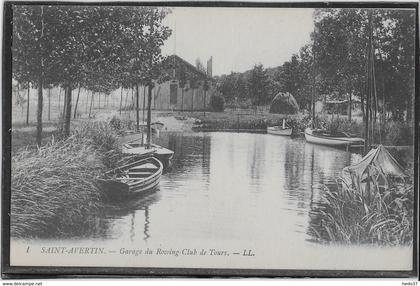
[310,174,414,246]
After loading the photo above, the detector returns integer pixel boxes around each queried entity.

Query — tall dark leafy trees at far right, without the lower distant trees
[314,9,415,120]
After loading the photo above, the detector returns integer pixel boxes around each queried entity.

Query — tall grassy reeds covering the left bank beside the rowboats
[11,122,121,238]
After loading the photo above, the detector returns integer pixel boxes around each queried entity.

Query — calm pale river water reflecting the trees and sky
[99,132,360,245]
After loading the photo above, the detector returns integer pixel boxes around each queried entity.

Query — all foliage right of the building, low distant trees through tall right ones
[216,8,416,120]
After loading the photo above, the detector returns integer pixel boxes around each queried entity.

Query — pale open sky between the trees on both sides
[163,7,313,75]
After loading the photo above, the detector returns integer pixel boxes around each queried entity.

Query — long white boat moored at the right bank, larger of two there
[305,128,364,147]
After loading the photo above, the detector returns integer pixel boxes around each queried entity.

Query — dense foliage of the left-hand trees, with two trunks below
[12,5,171,141]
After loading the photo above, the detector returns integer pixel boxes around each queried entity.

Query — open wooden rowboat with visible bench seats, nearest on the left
[97,157,163,200]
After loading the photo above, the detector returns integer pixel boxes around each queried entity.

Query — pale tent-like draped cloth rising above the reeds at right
[342,145,406,190]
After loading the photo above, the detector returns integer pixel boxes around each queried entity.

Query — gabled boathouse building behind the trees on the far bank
[151,55,215,111]
